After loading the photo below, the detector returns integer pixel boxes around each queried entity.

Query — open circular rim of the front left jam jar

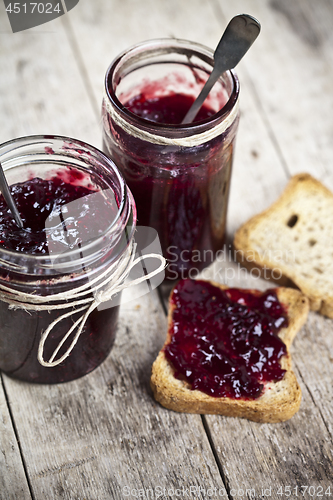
[0,134,136,272]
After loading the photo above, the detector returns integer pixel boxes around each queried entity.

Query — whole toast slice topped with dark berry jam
[151,280,309,423]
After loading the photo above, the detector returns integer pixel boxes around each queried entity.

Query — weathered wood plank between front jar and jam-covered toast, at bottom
[1,288,226,500]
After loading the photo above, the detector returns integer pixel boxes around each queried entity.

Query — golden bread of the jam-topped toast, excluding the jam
[150,282,309,422]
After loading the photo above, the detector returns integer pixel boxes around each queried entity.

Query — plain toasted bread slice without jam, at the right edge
[234,174,333,318]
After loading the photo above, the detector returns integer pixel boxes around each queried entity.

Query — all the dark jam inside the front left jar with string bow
[0,172,119,383]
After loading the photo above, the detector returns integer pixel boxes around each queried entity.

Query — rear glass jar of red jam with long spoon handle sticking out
[102,39,239,280]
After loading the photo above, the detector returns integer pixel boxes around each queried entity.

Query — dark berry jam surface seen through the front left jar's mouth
[0,175,116,254]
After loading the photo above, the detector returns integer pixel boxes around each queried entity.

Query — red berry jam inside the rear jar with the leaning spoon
[104,87,237,280]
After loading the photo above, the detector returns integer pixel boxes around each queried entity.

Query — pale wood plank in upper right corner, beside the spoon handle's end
[213,0,333,189]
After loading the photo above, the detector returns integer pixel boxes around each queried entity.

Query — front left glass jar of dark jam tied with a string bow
[0,135,136,383]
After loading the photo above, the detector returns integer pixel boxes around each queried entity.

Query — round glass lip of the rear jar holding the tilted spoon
[104,38,240,135]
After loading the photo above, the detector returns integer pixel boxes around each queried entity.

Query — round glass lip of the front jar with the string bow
[0,134,137,269]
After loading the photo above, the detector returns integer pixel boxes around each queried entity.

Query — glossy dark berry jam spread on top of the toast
[164,280,288,399]
